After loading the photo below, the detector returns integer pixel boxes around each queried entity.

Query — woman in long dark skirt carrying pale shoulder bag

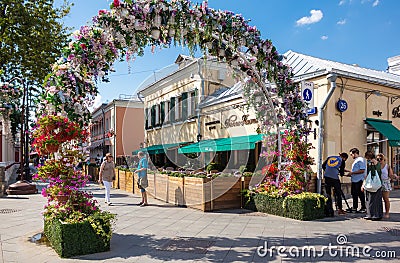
[363,151,383,220]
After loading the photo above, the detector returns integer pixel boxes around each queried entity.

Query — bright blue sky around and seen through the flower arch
[56,0,400,102]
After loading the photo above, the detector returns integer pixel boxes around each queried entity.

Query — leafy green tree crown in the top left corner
[0,0,71,85]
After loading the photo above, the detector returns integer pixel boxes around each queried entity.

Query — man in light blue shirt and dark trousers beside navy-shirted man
[347,148,367,213]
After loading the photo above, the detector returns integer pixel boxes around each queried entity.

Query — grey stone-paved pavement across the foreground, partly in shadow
[0,184,400,263]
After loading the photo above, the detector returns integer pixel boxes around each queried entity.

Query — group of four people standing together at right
[322,148,398,220]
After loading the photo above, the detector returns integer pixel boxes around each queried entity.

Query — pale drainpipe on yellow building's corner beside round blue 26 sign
[317,73,337,193]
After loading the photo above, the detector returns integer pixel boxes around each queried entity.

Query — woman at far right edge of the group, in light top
[376,153,398,218]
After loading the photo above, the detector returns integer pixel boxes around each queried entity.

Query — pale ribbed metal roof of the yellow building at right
[282,50,400,88]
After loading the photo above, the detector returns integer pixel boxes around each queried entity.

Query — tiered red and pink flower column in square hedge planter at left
[33,115,115,257]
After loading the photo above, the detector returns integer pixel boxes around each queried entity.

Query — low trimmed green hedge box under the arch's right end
[254,192,326,221]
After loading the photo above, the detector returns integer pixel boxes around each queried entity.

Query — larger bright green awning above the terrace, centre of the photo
[178,134,264,153]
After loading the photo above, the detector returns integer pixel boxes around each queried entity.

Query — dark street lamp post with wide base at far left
[7,77,38,195]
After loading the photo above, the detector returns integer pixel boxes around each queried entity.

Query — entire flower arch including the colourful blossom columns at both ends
[33,0,307,243]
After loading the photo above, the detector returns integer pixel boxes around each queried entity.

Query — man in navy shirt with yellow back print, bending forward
[322,153,349,216]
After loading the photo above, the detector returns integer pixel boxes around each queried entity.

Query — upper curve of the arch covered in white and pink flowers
[42,0,307,134]
